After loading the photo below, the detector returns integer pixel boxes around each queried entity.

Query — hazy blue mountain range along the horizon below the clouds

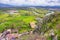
[0,3,60,9]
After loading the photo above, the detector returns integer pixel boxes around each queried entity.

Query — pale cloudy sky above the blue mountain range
[0,0,60,6]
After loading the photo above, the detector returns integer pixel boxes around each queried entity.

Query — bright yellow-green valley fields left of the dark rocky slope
[0,8,47,32]
